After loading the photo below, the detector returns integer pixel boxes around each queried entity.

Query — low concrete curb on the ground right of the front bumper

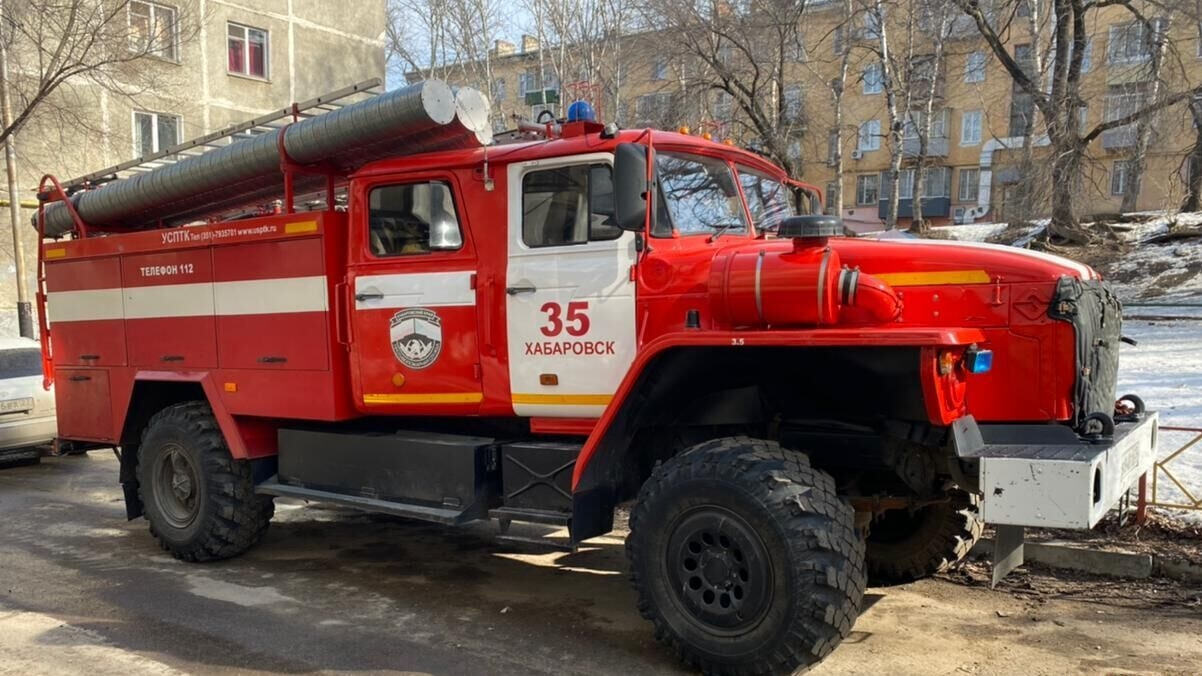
[969,538,1202,582]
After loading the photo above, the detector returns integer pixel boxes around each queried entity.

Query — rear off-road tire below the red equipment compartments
[137,402,275,562]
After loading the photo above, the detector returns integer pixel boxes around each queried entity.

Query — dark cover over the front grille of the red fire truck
[1048,271,1123,432]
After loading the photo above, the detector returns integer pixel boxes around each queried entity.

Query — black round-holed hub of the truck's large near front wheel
[666,505,773,633]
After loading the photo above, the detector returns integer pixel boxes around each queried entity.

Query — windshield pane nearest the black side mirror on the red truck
[654,153,748,236]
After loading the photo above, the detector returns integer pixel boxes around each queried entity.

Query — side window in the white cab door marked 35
[522,164,621,247]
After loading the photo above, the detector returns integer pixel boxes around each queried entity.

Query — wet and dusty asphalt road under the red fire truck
[0,452,1202,676]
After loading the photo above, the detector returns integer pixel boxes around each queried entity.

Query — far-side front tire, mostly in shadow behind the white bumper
[868,491,984,585]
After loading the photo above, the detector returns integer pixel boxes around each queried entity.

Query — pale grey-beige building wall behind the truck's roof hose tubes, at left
[0,0,387,336]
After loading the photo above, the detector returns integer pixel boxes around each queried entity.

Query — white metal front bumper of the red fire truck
[953,411,1159,528]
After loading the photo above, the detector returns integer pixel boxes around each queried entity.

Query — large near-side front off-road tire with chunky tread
[626,437,865,675]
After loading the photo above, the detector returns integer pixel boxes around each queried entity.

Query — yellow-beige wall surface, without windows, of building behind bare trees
[463,4,1202,224]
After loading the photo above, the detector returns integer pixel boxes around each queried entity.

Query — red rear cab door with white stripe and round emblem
[347,176,483,414]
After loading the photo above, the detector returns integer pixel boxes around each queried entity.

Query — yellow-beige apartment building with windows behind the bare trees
[456,0,1202,229]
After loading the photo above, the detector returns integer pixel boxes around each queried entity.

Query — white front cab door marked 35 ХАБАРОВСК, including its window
[506,153,637,417]
